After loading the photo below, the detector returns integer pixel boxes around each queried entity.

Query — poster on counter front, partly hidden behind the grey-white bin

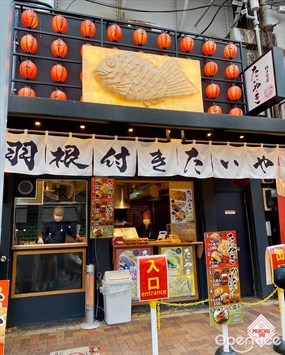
[114,247,153,301]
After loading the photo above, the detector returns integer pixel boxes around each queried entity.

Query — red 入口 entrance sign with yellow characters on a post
[137,255,169,301]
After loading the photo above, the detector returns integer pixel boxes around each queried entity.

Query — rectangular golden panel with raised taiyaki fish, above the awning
[83,45,203,112]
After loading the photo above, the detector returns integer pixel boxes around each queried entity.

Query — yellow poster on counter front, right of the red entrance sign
[159,246,196,299]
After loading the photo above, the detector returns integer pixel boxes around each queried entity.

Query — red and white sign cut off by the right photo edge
[265,244,285,285]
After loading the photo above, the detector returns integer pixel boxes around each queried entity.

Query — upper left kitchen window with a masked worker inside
[14,180,87,245]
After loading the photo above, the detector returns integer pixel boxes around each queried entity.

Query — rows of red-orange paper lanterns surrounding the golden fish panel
[18,9,243,116]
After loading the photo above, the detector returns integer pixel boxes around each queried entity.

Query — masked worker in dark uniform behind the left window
[37,206,85,244]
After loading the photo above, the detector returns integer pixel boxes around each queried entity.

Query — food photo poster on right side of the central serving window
[169,189,194,223]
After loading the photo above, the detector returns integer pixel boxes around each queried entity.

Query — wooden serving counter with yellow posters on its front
[113,240,203,304]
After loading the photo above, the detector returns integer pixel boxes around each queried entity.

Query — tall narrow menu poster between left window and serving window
[90,177,114,239]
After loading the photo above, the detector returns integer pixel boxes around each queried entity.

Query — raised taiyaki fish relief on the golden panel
[94,52,198,106]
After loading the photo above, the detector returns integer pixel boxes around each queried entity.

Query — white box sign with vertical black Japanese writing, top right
[244,47,285,115]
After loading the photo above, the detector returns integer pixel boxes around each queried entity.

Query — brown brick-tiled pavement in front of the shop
[5,300,281,355]
